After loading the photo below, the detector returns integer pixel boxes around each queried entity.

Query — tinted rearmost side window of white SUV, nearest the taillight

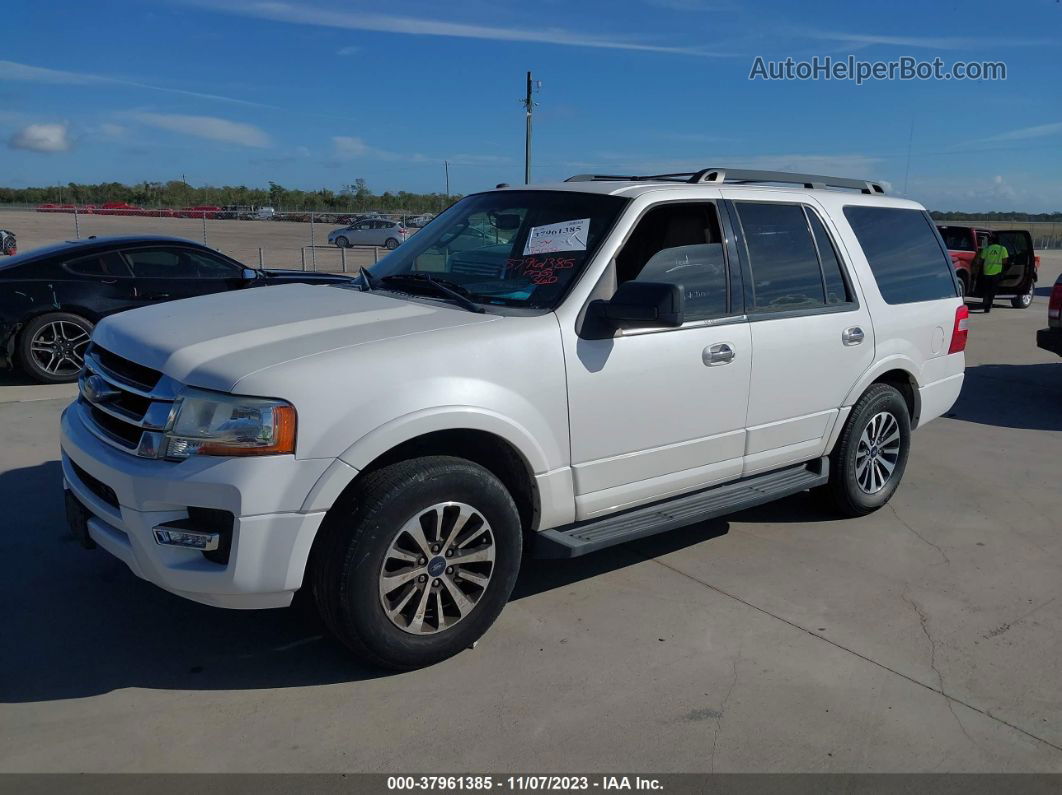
[844,205,958,304]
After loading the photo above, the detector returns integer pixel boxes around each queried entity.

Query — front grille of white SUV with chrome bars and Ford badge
[78,343,177,457]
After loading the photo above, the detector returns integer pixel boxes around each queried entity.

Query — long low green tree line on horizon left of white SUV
[0,179,460,212]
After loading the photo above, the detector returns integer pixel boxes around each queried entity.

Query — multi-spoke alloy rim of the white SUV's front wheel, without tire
[379,502,495,635]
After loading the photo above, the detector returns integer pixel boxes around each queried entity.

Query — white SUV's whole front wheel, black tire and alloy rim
[308,455,523,671]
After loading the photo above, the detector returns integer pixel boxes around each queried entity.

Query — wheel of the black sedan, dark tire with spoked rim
[18,312,92,383]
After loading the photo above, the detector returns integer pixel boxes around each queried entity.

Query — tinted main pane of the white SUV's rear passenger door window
[737,202,825,312]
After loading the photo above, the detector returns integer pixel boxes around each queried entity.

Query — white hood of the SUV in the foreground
[92,284,497,392]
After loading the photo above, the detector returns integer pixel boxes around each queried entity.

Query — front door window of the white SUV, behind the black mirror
[616,204,726,321]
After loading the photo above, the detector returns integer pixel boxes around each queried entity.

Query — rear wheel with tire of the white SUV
[824,384,911,516]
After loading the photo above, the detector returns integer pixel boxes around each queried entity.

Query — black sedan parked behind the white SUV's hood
[0,237,349,383]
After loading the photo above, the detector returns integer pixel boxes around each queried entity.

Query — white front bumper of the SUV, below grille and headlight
[62,410,331,608]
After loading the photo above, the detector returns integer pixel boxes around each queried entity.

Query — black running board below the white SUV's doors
[531,457,829,558]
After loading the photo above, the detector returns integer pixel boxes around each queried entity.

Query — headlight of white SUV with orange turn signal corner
[166,390,295,459]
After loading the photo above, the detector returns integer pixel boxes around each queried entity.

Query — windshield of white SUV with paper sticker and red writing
[371,190,628,309]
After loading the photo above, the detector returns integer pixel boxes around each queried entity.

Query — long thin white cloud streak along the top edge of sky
[187,0,723,56]
